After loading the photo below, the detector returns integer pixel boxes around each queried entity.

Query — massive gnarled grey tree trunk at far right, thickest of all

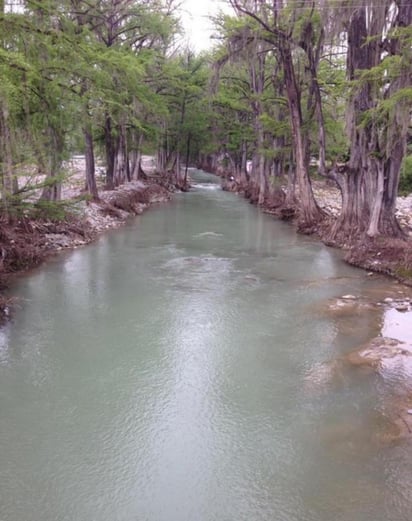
[331,0,412,240]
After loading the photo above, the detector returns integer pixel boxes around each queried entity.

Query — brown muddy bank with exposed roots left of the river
[0,180,171,321]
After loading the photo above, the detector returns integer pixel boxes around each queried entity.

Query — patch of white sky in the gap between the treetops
[181,0,225,51]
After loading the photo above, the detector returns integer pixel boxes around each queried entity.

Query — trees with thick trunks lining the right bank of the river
[204,0,412,241]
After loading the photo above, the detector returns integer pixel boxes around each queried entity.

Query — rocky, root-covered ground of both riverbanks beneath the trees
[0,167,412,318]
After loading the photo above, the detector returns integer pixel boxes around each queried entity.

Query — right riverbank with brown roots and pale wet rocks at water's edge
[223,176,412,438]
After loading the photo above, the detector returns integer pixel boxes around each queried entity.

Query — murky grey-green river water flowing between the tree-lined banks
[0,173,412,521]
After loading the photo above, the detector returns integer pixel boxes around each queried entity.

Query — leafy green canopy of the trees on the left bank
[0,0,183,214]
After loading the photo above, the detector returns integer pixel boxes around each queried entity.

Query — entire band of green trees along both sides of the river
[0,0,412,242]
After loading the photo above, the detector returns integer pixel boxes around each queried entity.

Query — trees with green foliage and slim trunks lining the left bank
[0,0,207,217]
